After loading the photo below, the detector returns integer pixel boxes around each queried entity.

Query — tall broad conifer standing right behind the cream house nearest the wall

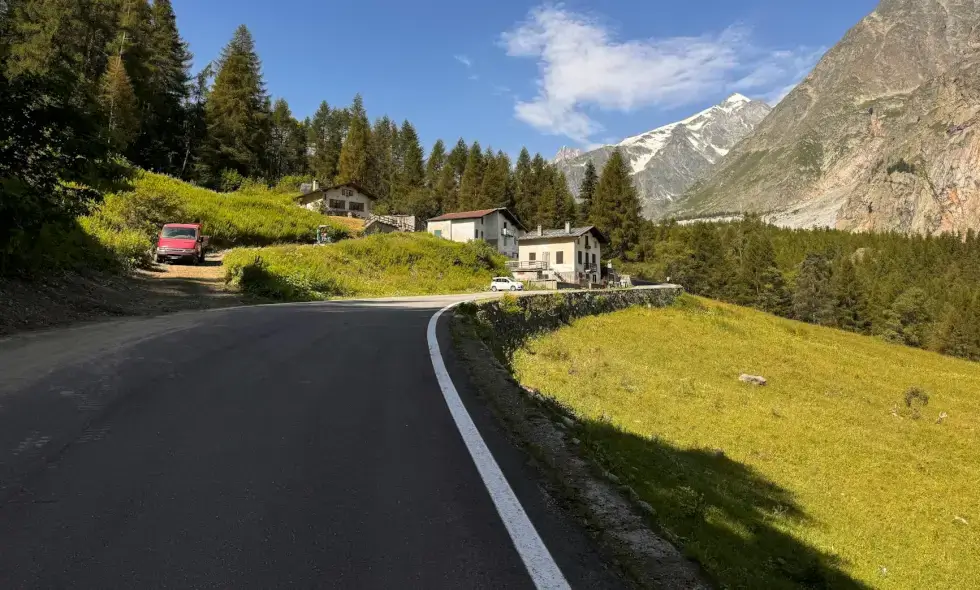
[590,150,641,258]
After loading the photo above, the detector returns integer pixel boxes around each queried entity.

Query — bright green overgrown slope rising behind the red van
[80,172,353,266]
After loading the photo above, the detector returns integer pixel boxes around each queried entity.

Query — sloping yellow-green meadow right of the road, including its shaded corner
[514,297,980,589]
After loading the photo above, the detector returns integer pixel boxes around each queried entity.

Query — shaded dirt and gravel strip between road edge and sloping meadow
[452,315,711,590]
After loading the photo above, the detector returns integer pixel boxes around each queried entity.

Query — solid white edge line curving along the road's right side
[426,303,570,590]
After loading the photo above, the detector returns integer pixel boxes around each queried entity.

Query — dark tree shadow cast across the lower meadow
[582,421,870,589]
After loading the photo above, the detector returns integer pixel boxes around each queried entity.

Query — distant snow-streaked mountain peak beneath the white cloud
[554,94,772,218]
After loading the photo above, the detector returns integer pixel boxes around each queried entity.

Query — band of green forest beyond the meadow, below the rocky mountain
[619,217,980,361]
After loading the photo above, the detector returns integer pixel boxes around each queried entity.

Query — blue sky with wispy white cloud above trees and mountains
[173,0,877,158]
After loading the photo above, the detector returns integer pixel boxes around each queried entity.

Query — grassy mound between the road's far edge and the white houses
[224,233,506,301]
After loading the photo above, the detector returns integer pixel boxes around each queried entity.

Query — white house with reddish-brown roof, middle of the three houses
[427,208,524,259]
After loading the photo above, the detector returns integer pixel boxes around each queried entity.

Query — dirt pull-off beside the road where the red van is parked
[0,252,250,336]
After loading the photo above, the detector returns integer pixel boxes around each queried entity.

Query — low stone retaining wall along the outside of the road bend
[459,285,683,362]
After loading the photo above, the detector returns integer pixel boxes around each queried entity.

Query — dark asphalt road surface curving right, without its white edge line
[0,298,618,588]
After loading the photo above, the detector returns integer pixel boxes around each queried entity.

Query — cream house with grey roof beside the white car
[511,223,607,285]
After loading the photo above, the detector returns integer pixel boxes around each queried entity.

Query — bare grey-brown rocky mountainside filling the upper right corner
[670,0,980,233]
